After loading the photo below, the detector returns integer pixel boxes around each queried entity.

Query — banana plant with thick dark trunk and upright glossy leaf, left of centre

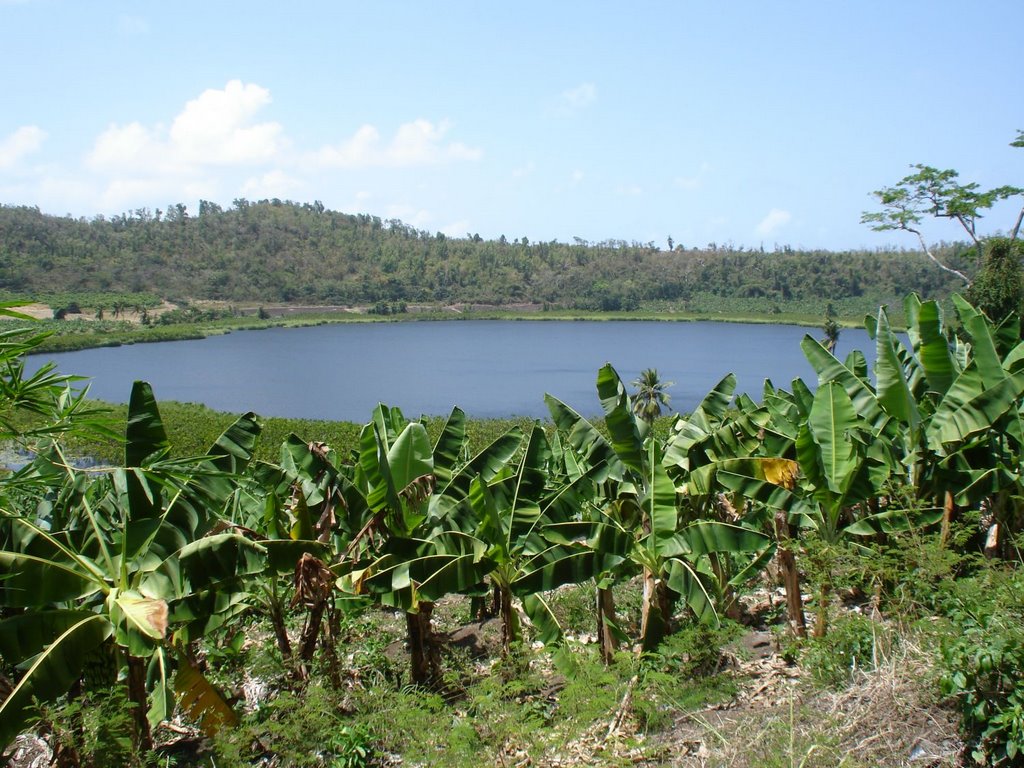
[339,406,509,685]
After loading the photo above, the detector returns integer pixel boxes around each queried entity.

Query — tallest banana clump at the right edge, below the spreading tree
[823,295,1024,548]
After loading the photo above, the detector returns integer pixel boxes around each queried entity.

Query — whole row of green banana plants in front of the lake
[0,296,1024,764]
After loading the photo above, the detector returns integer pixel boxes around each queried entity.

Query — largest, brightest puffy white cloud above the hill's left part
[87,80,288,175]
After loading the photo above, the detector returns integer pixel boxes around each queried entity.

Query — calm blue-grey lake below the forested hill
[28,321,873,422]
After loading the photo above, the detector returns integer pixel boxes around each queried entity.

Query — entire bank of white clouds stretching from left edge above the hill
[12,79,482,221]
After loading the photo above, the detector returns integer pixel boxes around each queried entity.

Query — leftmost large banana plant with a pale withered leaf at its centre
[0,382,264,748]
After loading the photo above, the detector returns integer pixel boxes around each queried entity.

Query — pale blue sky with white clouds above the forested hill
[0,0,1024,249]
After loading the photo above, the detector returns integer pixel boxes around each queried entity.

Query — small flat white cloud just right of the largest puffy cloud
[313,118,483,168]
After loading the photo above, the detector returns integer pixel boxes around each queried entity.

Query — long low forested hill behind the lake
[0,200,970,310]
